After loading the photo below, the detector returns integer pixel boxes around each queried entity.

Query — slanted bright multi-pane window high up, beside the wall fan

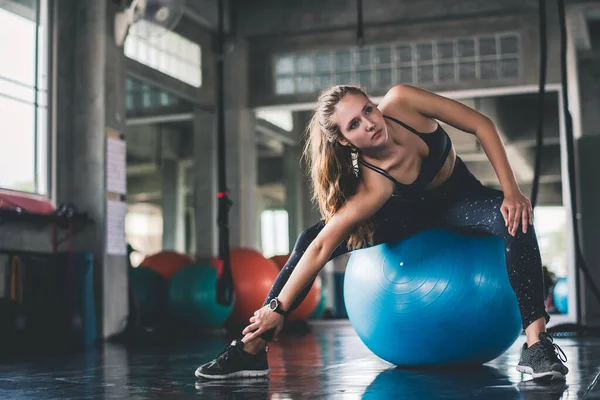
[125,21,202,87]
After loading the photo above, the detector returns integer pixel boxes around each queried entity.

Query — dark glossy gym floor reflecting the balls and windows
[0,322,600,399]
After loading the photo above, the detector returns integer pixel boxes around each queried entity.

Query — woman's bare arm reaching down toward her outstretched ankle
[242,178,393,343]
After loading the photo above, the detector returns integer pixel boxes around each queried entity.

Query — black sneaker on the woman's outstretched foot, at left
[195,340,269,379]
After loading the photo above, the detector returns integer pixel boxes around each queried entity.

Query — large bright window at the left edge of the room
[0,0,49,194]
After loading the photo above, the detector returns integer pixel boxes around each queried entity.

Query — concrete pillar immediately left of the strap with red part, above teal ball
[193,110,219,261]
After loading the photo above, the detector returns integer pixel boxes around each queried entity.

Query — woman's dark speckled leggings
[265,158,550,328]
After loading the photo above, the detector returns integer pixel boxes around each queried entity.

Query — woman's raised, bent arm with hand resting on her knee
[386,85,532,235]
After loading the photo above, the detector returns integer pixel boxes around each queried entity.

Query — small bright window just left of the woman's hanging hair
[260,210,290,258]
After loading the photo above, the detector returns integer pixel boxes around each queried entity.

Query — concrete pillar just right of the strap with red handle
[225,39,255,249]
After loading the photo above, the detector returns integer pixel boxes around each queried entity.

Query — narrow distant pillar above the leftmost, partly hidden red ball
[161,159,185,253]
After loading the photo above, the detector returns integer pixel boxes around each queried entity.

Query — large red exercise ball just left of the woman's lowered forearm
[213,248,279,326]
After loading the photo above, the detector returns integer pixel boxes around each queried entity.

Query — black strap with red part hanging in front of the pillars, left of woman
[216,0,233,305]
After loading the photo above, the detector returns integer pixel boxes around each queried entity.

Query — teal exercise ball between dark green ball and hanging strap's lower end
[169,264,233,329]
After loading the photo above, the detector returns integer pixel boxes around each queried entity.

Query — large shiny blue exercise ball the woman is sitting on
[344,229,522,366]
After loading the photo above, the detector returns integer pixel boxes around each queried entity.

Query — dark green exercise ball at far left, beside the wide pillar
[129,266,167,327]
